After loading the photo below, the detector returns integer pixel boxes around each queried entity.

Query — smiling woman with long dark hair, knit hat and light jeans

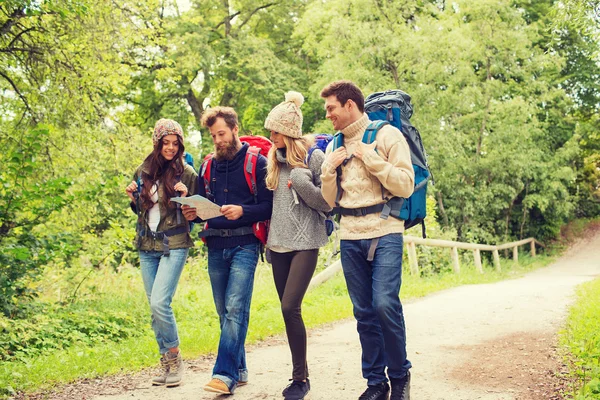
[125,119,198,386]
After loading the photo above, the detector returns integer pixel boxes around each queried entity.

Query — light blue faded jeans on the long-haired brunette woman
[140,249,189,354]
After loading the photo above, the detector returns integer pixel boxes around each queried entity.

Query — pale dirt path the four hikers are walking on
[39,234,600,400]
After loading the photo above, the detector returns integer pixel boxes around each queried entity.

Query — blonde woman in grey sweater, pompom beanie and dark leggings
[265,92,331,400]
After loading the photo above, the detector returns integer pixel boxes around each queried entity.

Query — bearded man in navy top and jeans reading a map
[183,107,273,394]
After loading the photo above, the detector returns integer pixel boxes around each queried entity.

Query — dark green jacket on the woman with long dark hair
[132,164,198,251]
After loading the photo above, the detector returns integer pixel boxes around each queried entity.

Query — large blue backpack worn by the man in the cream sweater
[333,90,433,237]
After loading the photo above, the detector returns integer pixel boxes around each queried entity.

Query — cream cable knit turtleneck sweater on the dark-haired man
[321,114,415,240]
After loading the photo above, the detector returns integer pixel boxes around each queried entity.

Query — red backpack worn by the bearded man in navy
[198,136,273,245]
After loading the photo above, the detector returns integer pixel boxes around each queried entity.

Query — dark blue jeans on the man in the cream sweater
[341,233,411,385]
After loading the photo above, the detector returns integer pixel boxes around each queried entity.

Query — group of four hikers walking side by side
[126,80,415,400]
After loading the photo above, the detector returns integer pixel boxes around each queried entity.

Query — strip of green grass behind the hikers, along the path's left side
[0,248,554,395]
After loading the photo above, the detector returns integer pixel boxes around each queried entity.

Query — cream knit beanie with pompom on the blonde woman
[265,92,304,138]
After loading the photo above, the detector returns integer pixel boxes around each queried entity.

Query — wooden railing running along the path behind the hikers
[308,236,544,290]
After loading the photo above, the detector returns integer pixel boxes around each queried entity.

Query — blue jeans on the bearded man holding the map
[208,244,260,392]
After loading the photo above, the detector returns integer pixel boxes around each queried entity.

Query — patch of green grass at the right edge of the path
[560,279,600,400]
